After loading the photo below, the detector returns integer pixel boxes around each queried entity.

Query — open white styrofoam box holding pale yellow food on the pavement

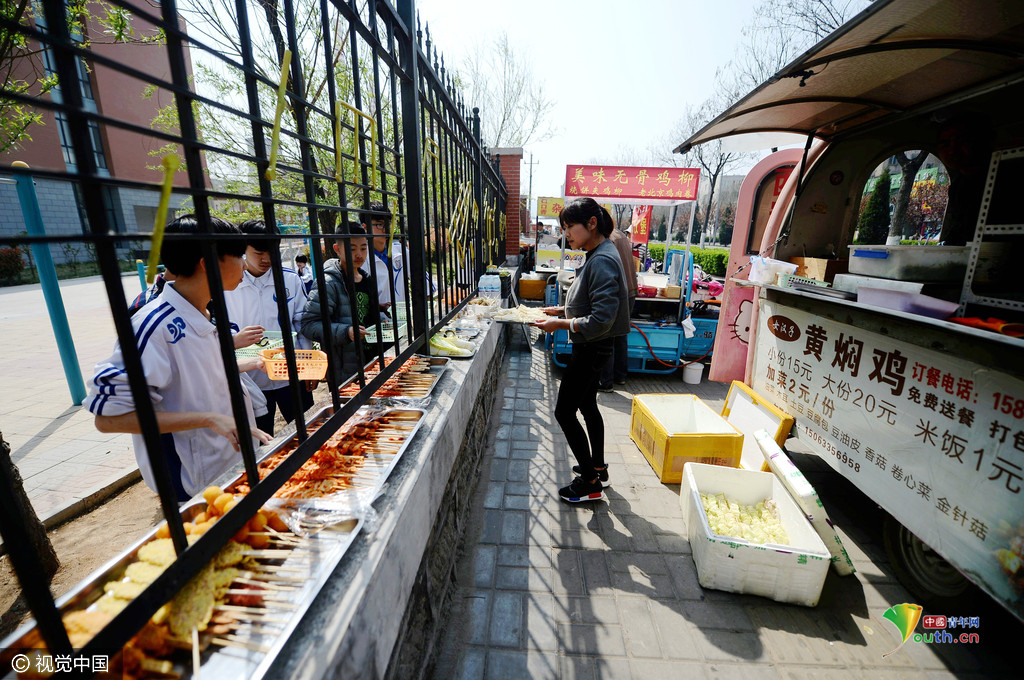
[679,463,830,606]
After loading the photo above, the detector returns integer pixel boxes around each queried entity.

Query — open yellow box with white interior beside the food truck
[630,394,743,484]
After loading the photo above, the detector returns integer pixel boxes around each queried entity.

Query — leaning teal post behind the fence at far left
[11,161,86,406]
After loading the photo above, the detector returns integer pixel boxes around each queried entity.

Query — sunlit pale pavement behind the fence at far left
[0,273,140,526]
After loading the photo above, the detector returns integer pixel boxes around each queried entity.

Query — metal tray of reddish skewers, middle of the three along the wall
[227,407,424,500]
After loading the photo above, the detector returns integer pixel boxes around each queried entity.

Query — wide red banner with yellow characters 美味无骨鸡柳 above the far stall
[565,165,700,203]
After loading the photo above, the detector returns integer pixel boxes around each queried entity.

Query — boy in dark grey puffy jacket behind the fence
[300,222,380,384]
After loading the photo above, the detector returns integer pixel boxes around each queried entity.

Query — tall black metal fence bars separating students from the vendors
[0,0,505,655]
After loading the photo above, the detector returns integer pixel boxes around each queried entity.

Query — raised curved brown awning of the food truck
[674,0,1024,154]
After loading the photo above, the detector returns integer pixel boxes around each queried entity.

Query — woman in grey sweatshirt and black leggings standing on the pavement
[536,198,630,503]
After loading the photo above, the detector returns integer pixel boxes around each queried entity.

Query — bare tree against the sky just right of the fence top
[457,33,555,146]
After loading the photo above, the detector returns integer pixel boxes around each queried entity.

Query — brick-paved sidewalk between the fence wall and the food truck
[432,343,1024,680]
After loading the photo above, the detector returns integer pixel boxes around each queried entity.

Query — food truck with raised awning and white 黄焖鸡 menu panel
[676,0,1024,619]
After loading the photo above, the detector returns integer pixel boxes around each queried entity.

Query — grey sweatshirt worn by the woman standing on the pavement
[565,239,630,342]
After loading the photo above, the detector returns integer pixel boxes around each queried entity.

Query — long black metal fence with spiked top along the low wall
[0,0,506,656]
